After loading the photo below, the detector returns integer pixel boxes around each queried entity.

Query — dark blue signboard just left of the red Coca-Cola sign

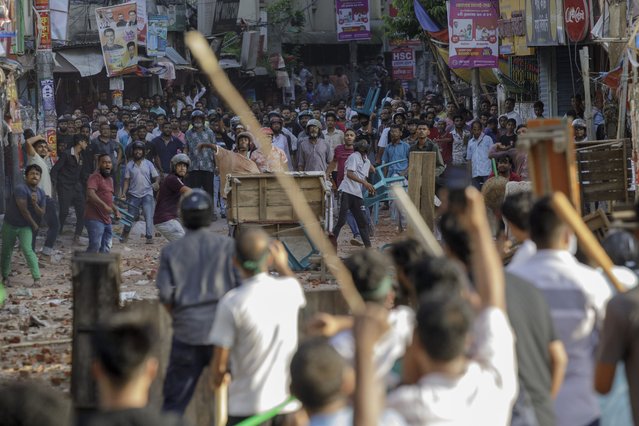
[525,0,564,46]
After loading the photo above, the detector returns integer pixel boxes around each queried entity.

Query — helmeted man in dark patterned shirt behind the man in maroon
[184,111,217,220]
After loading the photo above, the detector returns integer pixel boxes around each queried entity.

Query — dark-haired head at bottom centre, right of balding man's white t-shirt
[290,338,347,412]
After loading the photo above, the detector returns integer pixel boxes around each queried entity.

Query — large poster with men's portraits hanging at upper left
[95,3,138,77]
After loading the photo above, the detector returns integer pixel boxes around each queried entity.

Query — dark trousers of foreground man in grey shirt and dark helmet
[162,337,213,415]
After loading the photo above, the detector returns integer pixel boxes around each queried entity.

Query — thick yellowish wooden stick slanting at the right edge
[551,192,626,292]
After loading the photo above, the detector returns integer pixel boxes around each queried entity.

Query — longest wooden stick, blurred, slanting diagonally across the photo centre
[185,31,364,313]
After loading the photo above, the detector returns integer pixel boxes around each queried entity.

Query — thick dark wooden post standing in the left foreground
[71,252,121,417]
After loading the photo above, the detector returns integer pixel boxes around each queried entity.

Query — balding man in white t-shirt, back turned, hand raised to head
[211,229,306,425]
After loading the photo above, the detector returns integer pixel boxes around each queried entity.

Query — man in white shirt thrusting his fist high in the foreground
[354,188,517,426]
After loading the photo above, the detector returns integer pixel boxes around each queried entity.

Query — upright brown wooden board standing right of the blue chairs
[408,152,436,232]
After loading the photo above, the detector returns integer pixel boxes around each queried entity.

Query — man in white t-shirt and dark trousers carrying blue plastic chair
[329,139,375,247]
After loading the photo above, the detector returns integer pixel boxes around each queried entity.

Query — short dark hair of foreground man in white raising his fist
[416,290,473,362]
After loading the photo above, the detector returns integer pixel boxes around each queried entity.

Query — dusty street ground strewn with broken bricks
[0,211,399,392]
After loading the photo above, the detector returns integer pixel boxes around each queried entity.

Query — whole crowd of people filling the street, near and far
[0,82,639,426]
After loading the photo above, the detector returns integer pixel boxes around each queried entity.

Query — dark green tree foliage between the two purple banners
[384,0,447,39]
